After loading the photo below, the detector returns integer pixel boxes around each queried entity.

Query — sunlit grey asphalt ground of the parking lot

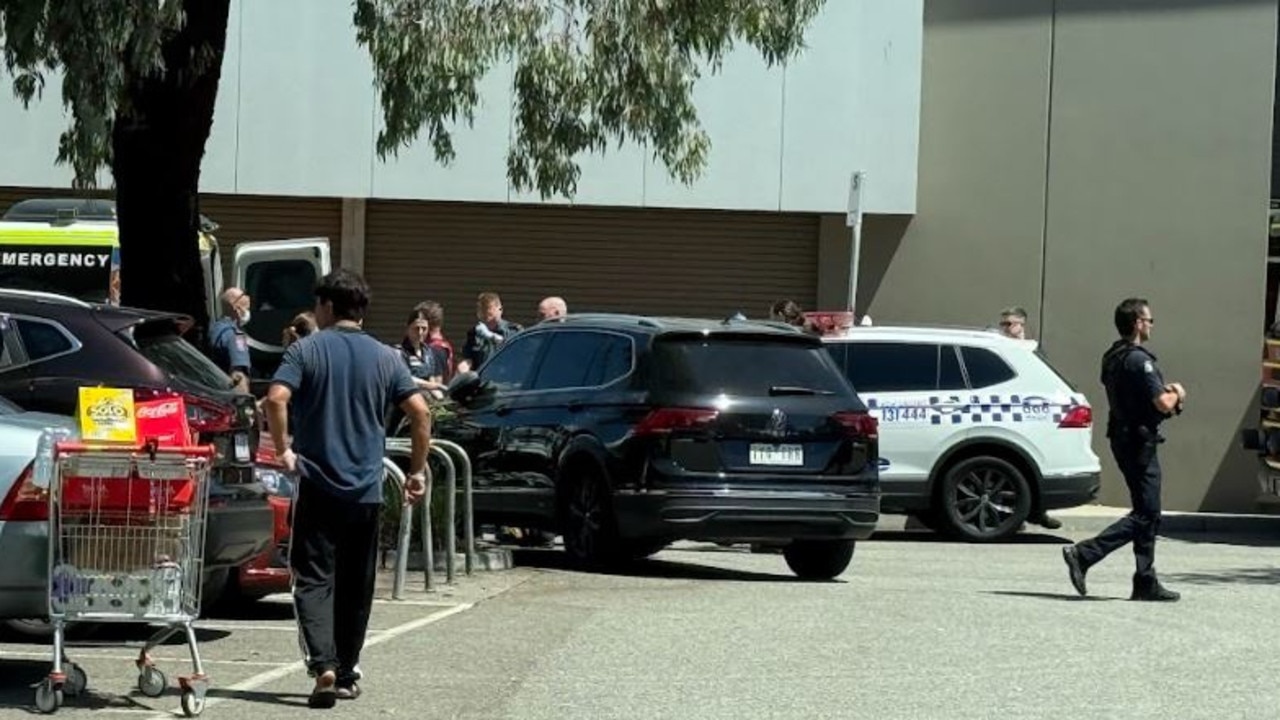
[0,520,1280,720]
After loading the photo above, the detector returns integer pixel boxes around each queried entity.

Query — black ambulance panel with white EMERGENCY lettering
[0,245,111,302]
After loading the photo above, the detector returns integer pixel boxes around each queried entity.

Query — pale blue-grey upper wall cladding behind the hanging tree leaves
[0,0,923,213]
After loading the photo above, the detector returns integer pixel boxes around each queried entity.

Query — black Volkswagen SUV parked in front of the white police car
[435,315,879,579]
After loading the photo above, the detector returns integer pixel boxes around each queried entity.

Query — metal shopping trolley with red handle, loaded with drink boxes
[36,442,212,717]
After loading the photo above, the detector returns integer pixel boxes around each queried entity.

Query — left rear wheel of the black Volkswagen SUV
[561,462,621,566]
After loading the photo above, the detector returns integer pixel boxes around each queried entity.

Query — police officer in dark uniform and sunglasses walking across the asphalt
[1062,297,1187,602]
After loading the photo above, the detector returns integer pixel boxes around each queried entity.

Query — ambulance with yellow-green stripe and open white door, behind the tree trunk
[0,197,332,377]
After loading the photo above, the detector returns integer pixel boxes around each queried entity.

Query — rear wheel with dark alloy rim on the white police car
[938,456,1032,542]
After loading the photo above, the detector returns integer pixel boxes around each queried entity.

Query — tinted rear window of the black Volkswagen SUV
[653,336,854,398]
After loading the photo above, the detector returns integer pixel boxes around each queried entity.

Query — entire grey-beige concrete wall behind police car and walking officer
[860,0,1276,510]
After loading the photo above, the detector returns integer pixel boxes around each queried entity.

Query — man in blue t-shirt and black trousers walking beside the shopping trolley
[266,269,431,707]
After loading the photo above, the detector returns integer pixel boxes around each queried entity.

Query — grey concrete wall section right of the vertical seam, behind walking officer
[1043,0,1276,510]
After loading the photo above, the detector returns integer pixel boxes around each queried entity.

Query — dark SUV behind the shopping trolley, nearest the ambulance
[0,290,273,586]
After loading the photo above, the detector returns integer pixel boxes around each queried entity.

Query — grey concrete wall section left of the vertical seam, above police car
[858,0,1052,329]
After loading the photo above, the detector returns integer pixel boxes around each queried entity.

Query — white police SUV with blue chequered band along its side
[823,327,1101,541]
